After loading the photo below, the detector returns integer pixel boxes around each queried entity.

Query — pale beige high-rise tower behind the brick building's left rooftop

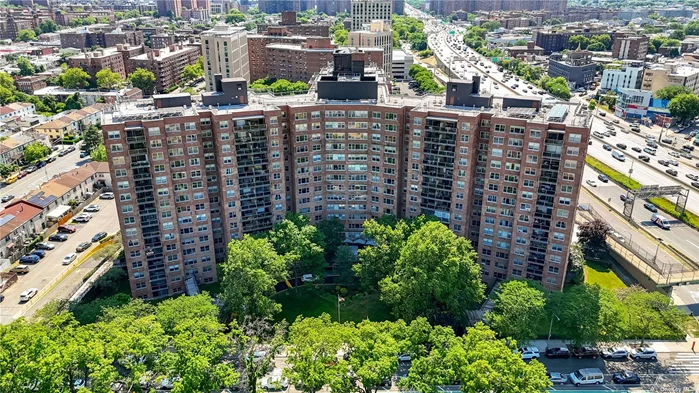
[201,25,250,91]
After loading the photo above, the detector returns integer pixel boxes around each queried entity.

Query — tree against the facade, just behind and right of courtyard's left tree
[269,213,325,278]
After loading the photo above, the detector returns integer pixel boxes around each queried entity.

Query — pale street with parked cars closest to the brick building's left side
[0,199,119,324]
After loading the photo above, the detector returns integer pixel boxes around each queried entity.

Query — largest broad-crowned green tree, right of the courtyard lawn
[379,222,484,323]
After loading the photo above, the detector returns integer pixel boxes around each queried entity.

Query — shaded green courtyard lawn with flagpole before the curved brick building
[274,285,394,322]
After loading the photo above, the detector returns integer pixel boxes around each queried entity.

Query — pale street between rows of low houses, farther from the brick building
[0,149,90,206]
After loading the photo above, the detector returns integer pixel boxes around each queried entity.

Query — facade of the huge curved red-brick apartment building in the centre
[103,58,589,298]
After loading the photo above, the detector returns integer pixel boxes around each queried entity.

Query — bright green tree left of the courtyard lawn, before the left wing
[220,235,287,320]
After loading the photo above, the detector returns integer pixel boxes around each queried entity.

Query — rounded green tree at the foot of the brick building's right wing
[485,280,546,344]
